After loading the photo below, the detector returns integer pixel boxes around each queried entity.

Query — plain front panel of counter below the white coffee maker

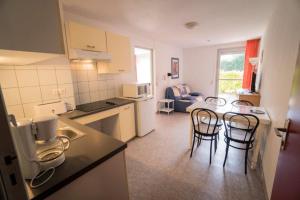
[46,151,129,200]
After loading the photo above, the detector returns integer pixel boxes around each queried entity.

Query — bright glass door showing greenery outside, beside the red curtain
[216,48,245,99]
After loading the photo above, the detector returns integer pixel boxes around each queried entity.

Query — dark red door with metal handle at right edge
[271,45,300,200]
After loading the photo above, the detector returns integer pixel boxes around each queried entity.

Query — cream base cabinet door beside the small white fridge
[119,104,136,142]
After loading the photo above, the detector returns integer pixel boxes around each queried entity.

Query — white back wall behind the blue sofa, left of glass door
[183,42,245,96]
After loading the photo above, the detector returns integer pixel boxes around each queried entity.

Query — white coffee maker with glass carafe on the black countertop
[11,114,70,187]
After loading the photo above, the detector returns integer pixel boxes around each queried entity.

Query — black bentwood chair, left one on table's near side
[190,108,219,164]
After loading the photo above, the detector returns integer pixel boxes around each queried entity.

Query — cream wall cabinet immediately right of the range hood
[98,32,131,74]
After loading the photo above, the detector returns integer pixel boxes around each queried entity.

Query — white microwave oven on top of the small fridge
[123,83,151,98]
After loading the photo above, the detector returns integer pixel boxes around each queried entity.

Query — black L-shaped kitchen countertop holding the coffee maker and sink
[26,98,133,199]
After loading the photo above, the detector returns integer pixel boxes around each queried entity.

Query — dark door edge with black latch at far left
[0,87,28,200]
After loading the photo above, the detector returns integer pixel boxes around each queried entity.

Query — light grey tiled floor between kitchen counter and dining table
[126,113,265,200]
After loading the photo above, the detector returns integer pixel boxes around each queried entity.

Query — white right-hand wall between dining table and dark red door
[260,0,300,198]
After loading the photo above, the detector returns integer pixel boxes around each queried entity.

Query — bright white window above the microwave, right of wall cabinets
[134,48,153,85]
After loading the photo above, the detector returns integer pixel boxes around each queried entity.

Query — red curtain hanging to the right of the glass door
[243,39,260,90]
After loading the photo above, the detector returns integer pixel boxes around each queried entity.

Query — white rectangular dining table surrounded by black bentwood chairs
[186,100,271,169]
